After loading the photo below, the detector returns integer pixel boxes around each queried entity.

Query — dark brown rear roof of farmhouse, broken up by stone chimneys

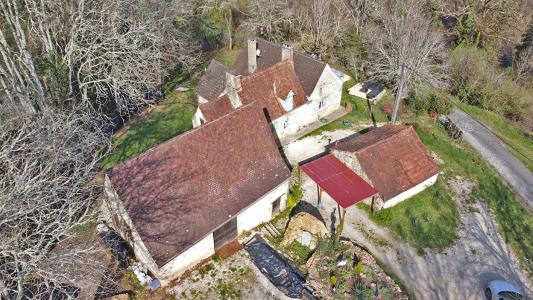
[233,38,326,96]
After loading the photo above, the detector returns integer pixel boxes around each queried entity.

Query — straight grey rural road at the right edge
[449,109,533,208]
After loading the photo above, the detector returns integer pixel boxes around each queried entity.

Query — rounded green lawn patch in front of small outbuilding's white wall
[372,179,459,254]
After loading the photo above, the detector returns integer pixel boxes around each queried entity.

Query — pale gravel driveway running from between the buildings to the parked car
[285,131,533,299]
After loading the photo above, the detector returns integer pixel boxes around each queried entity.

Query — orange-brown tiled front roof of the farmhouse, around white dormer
[200,61,307,122]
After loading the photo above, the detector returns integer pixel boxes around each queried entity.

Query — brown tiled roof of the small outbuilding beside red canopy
[333,125,439,201]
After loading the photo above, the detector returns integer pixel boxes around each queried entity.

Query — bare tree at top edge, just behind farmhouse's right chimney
[294,0,349,56]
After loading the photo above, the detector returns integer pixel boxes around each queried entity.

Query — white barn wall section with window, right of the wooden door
[237,178,290,233]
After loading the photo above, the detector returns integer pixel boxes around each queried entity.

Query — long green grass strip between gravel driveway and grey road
[416,120,533,279]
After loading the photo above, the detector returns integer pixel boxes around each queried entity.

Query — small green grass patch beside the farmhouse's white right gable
[299,79,393,139]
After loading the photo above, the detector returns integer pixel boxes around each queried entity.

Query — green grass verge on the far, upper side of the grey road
[454,101,533,172]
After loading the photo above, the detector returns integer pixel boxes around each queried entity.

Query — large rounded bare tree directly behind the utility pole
[364,0,447,92]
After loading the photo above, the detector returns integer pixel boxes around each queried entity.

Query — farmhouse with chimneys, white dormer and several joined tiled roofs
[192,39,348,143]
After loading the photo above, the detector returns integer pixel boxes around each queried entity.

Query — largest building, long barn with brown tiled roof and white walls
[102,102,290,285]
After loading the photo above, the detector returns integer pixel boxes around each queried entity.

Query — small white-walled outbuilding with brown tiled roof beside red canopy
[331,125,439,210]
